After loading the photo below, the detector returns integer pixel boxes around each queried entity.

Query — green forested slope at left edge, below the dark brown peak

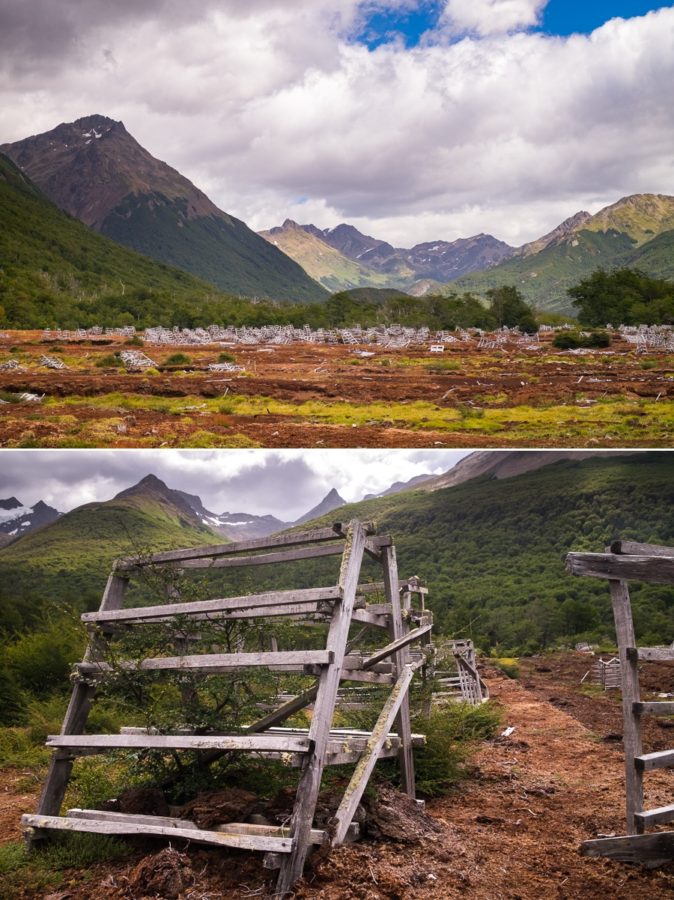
[0,154,228,327]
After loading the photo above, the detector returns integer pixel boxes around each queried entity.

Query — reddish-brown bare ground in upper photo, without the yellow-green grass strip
[0,332,674,447]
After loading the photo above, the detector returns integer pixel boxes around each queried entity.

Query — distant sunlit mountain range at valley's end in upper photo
[260,194,674,313]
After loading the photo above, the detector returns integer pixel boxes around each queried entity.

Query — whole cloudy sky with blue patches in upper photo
[0,0,674,246]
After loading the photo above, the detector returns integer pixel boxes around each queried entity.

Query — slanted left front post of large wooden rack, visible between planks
[34,572,129,828]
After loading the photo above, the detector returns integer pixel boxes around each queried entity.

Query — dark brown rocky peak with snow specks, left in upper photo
[0,115,325,302]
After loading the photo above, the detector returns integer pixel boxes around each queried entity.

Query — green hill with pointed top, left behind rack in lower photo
[0,476,226,631]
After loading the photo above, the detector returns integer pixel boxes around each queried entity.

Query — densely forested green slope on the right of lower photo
[298,453,674,651]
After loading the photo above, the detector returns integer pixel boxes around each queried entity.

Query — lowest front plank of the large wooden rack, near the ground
[21,815,293,853]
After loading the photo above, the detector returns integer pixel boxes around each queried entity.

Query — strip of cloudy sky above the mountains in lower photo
[0,450,467,521]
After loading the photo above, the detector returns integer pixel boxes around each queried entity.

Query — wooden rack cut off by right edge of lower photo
[566,541,674,865]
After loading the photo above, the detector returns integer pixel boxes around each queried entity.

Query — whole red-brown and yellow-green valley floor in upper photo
[0,332,674,448]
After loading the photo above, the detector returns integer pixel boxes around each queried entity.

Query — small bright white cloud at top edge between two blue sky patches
[442,0,548,35]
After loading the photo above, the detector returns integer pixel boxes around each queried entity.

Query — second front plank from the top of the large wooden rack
[81,587,341,624]
